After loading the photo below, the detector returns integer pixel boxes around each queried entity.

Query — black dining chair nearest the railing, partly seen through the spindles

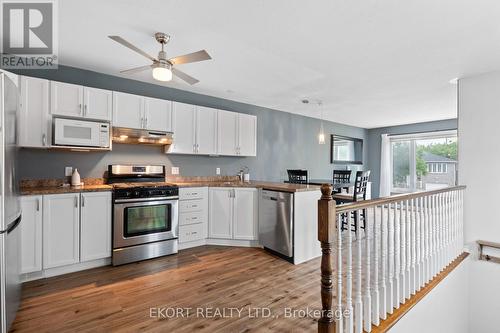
[333,170,370,232]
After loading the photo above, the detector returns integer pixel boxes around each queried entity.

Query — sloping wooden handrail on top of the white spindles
[334,184,466,213]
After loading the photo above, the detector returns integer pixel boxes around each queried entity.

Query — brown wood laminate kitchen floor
[11,246,321,332]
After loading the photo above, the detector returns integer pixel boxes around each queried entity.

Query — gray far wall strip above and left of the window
[365,119,458,197]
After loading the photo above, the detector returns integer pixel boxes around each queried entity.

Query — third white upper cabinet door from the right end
[196,106,217,155]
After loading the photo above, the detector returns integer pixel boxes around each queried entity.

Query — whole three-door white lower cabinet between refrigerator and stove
[21,191,112,274]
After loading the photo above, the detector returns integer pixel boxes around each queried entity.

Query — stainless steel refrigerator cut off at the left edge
[0,71,21,333]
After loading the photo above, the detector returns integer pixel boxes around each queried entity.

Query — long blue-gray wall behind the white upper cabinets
[17,66,368,181]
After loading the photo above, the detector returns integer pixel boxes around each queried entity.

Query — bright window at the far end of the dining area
[390,131,457,193]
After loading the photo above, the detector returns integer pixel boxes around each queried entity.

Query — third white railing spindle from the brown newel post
[363,209,374,332]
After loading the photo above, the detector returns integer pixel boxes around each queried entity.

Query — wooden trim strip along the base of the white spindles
[372,252,469,333]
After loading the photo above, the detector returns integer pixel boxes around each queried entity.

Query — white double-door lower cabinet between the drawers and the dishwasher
[208,188,258,240]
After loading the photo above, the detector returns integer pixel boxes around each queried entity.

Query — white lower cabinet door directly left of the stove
[80,192,111,262]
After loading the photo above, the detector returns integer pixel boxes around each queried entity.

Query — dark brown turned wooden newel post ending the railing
[318,184,336,333]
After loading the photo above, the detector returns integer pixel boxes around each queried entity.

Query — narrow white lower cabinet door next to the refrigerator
[20,195,42,274]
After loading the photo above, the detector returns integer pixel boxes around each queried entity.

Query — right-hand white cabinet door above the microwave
[83,87,113,121]
